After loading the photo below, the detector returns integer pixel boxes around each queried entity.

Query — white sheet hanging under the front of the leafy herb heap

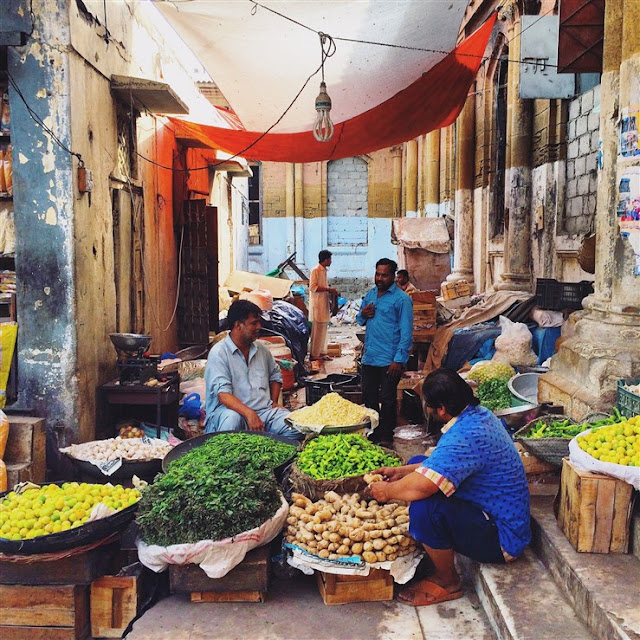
[137,496,289,578]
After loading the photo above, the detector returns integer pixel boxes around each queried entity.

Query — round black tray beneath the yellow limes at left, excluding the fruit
[0,482,138,555]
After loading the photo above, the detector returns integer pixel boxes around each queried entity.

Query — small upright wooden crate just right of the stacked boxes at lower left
[91,562,152,638]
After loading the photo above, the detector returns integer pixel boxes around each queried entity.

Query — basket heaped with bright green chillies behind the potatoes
[290,433,402,500]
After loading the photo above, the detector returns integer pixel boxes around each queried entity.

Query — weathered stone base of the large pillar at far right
[538,316,640,420]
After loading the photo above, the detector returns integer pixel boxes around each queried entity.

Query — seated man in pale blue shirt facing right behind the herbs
[204,300,302,439]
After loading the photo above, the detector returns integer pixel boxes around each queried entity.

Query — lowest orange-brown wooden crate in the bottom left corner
[0,584,89,640]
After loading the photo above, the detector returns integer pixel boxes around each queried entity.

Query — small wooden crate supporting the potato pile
[316,569,393,604]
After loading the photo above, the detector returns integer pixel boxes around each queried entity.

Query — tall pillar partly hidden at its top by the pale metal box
[496,17,532,291]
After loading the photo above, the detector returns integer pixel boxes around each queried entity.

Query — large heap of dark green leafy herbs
[137,433,295,546]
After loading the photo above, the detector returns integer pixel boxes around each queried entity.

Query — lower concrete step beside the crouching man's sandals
[458,549,600,640]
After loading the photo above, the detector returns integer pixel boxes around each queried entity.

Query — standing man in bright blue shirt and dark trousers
[357,258,413,445]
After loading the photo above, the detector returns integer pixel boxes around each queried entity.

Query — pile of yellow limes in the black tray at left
[0,482,140,540]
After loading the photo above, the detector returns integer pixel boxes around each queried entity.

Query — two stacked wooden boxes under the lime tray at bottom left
[0,543,118,640]
